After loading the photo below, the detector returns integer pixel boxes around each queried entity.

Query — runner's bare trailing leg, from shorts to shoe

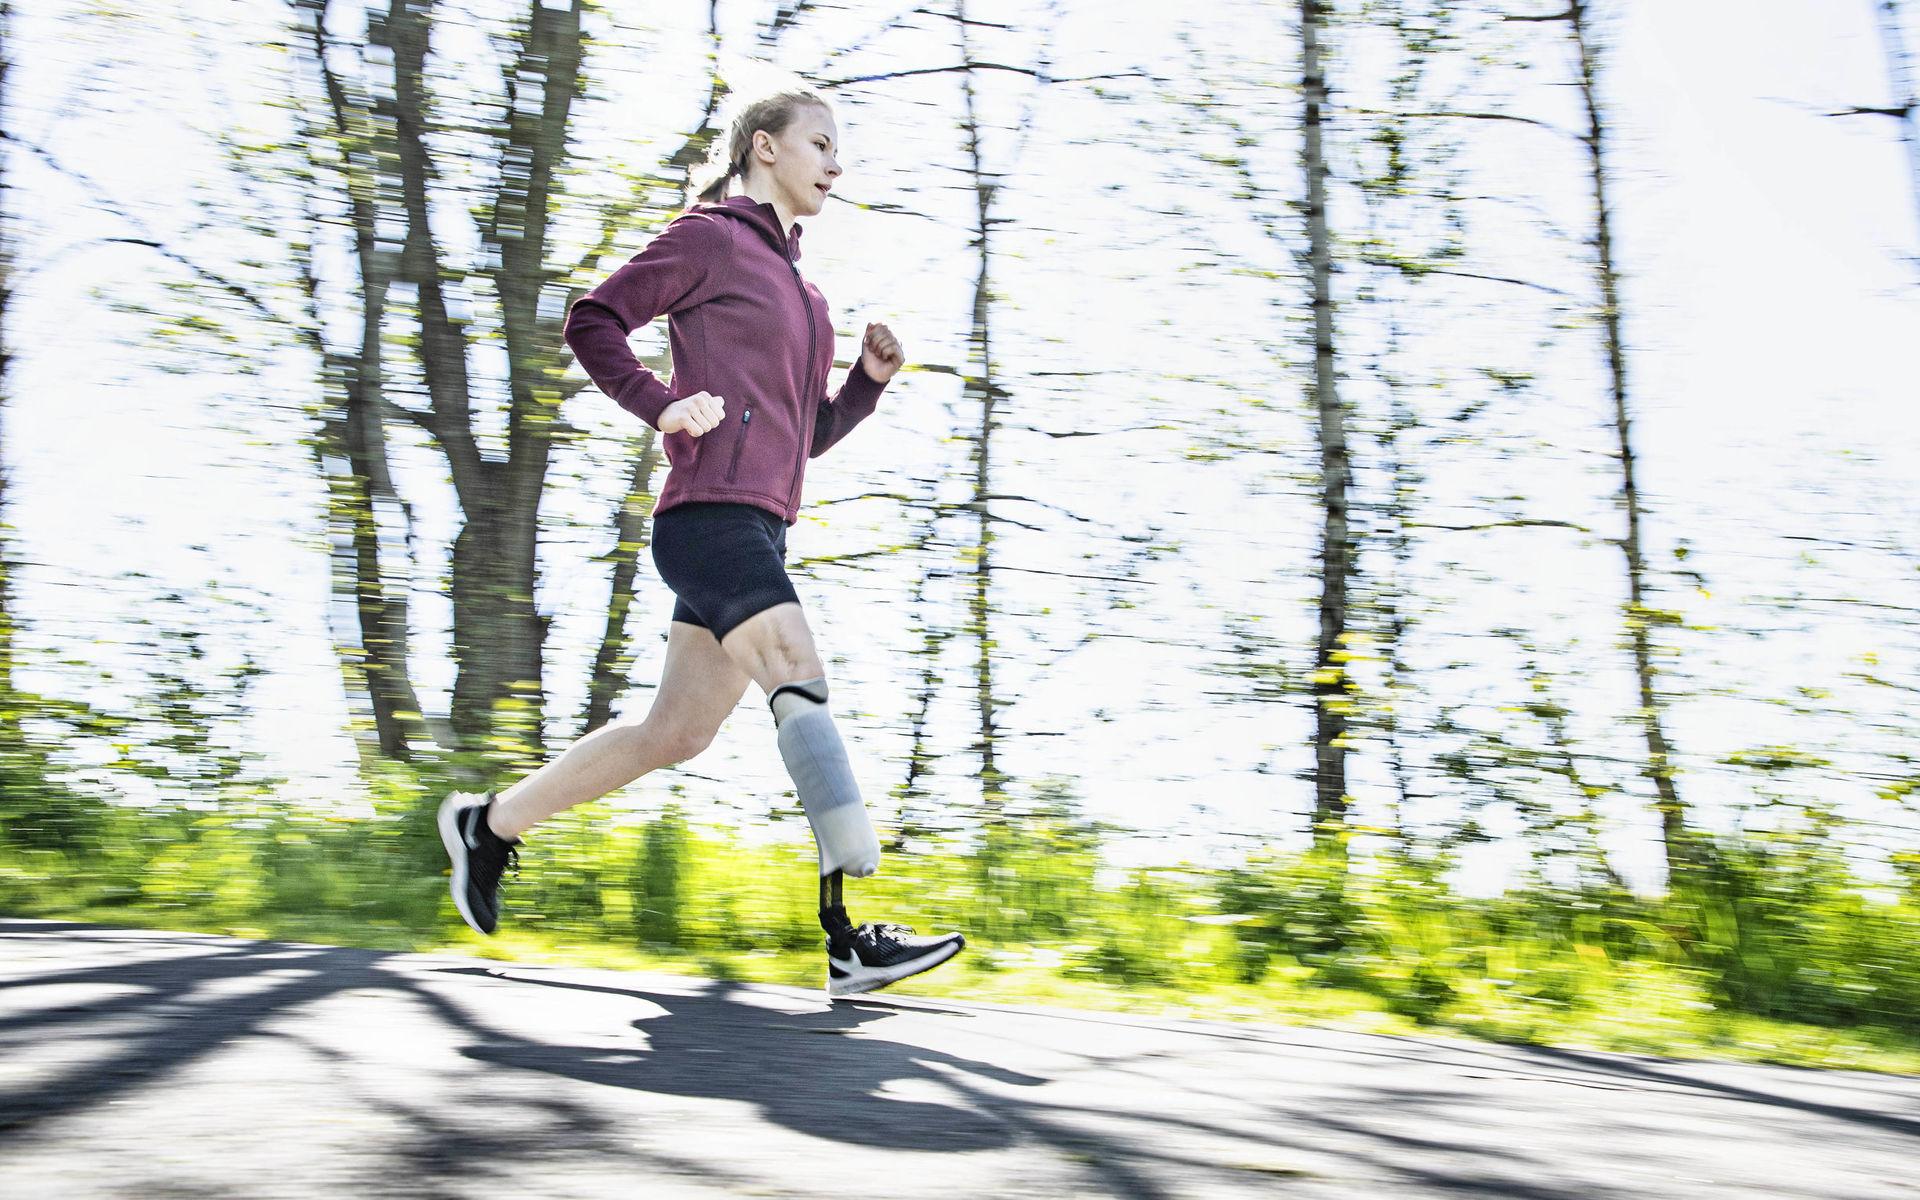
[488,622,748,837]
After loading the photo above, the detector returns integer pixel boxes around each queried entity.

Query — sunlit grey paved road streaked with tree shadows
[0,920,1920,1200]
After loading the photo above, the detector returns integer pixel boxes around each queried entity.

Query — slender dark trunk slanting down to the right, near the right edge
[1567,0,1695,879]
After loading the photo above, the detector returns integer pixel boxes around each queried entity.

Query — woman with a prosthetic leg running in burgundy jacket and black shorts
[440,88,966,996]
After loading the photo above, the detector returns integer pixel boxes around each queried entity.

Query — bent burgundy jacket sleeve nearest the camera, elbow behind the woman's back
[563,213,732,428]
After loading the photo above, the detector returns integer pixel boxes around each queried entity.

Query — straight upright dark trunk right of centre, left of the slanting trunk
[1300,0,1354,854]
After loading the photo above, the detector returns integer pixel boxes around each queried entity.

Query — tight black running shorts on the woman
[653,501,801,637]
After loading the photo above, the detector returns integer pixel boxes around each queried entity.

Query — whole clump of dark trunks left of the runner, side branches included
[127,0,622,776]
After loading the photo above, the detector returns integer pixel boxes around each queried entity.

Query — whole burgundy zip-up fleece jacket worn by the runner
[566,196,885,524]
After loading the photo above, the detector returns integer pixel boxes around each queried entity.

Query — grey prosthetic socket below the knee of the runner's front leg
[768,680,879,879]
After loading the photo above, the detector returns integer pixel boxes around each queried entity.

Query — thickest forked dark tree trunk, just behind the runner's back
[369,0,597,768]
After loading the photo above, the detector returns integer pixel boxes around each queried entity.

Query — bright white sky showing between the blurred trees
[6,0,1920,885]
